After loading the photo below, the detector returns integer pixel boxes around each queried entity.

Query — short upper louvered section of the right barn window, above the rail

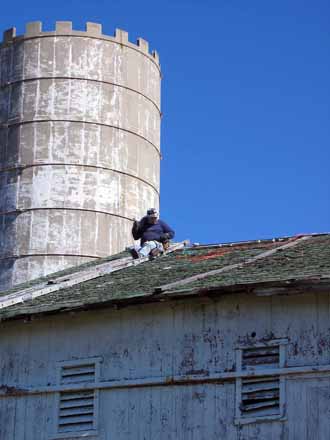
[242,345,280,369]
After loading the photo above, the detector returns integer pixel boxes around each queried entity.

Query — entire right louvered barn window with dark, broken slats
[236,340,287,424]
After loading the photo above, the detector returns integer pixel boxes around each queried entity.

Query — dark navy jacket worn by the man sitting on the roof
[132,216,174,246]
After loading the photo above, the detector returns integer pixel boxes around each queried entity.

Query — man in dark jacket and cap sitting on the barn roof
[130,208,174,259]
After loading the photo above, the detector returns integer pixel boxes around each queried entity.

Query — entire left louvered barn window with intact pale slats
[55,358,100,438]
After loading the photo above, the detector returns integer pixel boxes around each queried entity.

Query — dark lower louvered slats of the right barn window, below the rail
[240,376,280,417]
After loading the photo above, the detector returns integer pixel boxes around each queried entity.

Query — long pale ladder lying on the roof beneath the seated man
[0,240,187,310]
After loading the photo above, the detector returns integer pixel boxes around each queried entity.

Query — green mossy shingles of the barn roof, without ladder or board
[0,235,330,319]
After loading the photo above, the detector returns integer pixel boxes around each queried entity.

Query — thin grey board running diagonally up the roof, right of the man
[154,235,313,293]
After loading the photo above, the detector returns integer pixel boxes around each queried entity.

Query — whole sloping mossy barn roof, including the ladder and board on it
[0,234,330,320]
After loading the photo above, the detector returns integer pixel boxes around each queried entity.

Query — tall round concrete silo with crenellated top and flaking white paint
[0,22,161,290]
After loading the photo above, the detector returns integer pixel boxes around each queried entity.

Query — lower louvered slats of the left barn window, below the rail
[58,390,95,433]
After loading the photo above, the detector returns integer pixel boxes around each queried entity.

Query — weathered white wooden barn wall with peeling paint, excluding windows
[0,294,330,440]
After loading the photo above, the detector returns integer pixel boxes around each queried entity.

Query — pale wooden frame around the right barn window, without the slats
[234,339,288,425]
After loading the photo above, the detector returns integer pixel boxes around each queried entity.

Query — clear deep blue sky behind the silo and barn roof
[0,0,330,243]
